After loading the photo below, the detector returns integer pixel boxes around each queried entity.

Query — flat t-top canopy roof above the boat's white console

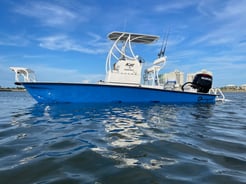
[108,32,159,44]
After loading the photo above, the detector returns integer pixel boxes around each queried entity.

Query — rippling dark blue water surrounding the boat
[0,92,246,184]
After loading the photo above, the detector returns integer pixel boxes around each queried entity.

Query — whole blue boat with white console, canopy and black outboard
[10,31,224,104]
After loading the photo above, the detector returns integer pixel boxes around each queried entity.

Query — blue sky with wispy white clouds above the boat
[0,0,246,87]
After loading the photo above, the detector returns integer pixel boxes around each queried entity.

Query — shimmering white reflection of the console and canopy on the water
[98,105,181,169]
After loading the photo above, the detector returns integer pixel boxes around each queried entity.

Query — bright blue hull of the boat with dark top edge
[18,82,216,104]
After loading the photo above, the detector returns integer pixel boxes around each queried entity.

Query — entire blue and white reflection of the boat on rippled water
[13,104,212,169]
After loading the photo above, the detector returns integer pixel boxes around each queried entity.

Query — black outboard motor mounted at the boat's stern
[181,73,213,93]
